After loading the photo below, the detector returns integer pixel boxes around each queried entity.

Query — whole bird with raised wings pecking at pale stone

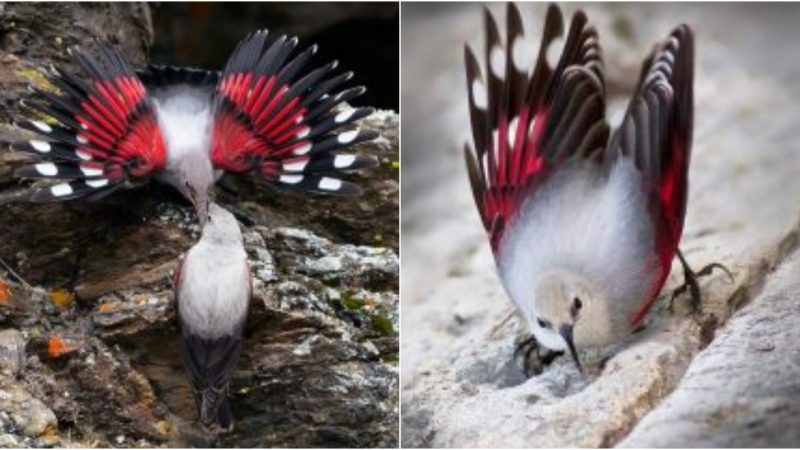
[465,4,732,372]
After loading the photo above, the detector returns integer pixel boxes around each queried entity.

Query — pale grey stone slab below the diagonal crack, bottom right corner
[619,253,800,447]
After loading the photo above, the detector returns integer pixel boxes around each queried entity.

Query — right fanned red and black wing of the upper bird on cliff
[212,30,377,194]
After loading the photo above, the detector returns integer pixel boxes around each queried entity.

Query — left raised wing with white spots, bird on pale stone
[465,4,608,252]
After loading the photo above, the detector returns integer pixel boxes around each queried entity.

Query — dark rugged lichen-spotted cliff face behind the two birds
[0,4,399,447]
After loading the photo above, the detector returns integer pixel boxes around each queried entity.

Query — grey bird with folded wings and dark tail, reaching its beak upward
[174,203,252,430]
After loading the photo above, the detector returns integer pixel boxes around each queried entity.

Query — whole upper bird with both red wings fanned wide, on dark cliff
[12,30,377,221]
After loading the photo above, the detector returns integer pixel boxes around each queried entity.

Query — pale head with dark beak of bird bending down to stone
[529,270,602,371]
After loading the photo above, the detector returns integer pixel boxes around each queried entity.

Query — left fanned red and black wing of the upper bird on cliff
[11,45,166,201]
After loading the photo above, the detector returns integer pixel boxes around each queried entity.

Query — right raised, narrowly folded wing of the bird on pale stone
[608,25,694,324]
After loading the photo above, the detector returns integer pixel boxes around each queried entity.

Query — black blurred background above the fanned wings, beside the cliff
[150,2,399,111]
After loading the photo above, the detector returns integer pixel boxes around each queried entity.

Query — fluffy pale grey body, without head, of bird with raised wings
[498,158,654,330]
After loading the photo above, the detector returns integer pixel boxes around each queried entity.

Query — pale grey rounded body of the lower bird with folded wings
[178,237,250,339]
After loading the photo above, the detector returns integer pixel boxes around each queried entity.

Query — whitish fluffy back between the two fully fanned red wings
[153,86,214,167]
